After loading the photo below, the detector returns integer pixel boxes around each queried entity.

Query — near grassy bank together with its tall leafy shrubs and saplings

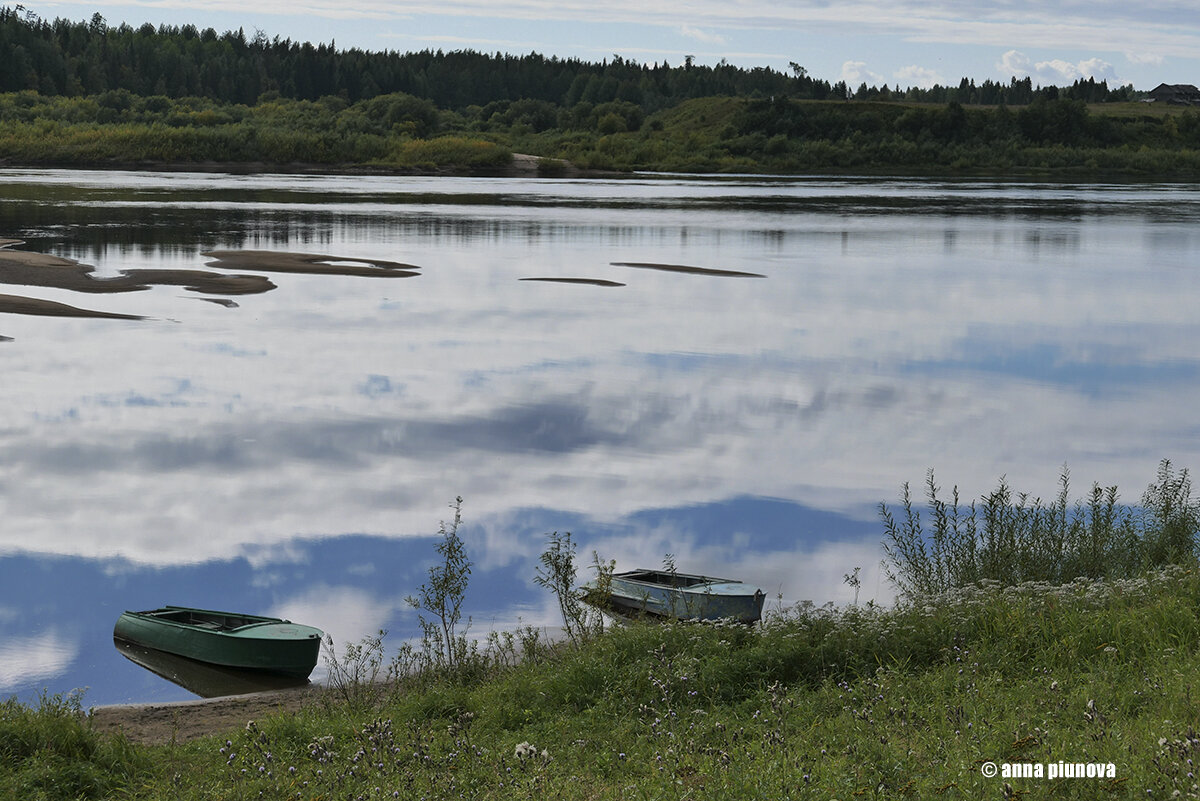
[9,470,1200,801]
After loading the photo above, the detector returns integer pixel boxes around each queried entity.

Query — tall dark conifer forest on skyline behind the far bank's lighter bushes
[0,8,845,112]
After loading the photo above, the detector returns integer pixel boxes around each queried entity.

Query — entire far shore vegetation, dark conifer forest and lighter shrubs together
[0,8,1200,179]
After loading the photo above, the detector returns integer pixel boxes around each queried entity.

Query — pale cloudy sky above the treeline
[16,0,1200,90]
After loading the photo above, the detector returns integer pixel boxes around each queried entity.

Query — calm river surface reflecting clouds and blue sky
[0,169,1200,705]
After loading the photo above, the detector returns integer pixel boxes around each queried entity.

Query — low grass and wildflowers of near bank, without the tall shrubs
[0,567,1200,799]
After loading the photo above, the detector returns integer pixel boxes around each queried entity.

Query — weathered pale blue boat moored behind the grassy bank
[584,570,766,624]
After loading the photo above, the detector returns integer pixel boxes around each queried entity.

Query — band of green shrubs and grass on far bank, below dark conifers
[0,90,1200,180]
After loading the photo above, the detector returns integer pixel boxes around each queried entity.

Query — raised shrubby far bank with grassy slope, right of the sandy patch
[614,98,1200,177]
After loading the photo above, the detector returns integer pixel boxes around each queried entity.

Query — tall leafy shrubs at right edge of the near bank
[880,459,1200,597]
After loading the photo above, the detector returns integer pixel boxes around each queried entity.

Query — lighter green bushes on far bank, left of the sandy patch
[0,90,501,168]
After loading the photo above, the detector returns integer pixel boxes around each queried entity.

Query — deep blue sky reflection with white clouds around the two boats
[0,498,890,705]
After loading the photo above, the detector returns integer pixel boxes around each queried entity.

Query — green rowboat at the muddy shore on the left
[113,607,324,677]
